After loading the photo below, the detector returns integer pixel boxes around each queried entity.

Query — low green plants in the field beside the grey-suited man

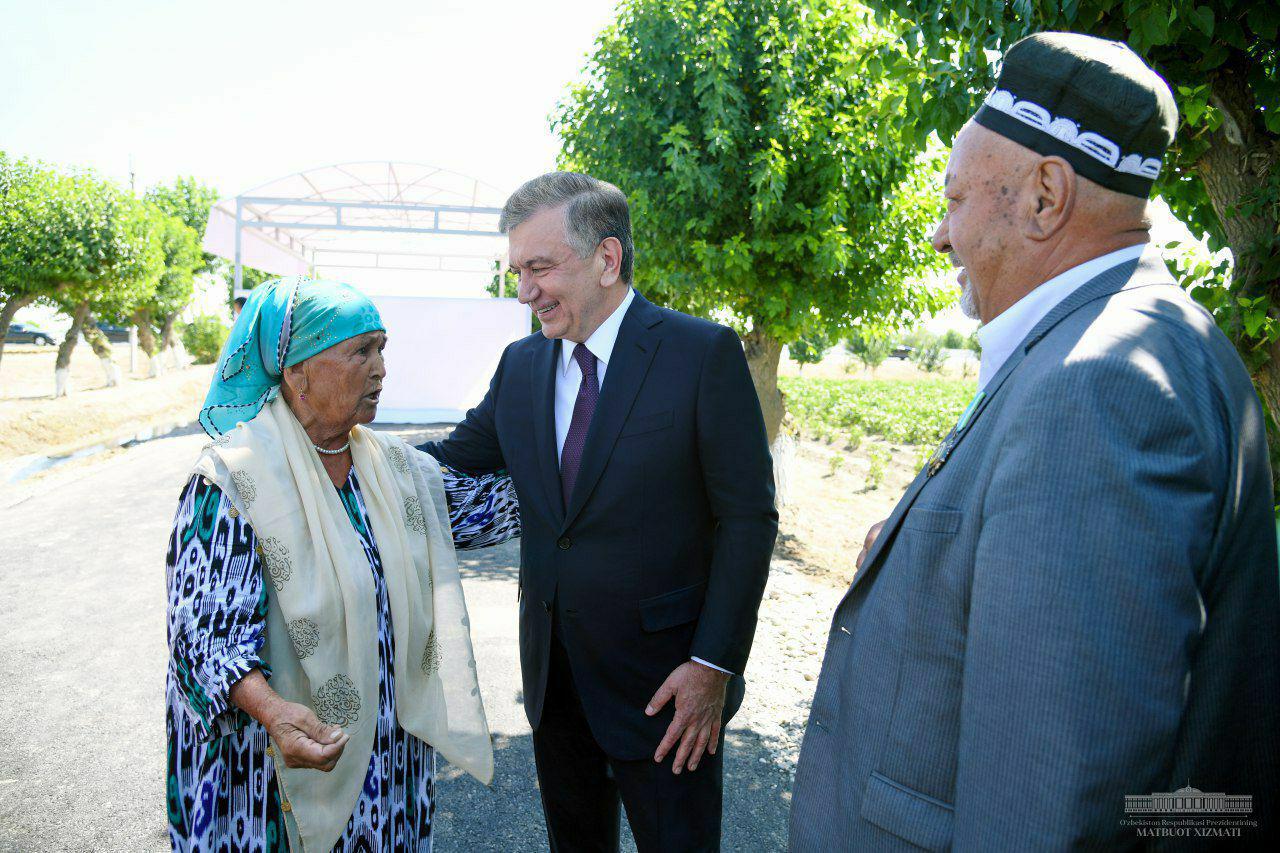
[778,377,978,444]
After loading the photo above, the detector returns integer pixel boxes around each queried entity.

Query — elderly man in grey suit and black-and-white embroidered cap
[791,33,1280,853]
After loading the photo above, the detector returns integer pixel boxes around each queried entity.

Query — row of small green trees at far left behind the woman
[0,152,218,394]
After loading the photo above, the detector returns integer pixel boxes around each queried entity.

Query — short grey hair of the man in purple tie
[498,172,635,284]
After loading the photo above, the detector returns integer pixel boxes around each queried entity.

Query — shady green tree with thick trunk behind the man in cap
[868,0,1280,484]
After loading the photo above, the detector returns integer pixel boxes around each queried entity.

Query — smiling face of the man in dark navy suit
[508,206,609,343]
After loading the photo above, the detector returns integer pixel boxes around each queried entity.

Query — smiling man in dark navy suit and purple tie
[422,172,777,852]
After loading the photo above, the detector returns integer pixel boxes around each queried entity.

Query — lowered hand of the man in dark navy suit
[644,661,730,775]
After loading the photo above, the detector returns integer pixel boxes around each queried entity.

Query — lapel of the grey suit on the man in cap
[842,252,1169,603]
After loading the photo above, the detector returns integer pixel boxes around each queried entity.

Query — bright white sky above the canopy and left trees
[0,0,614,196]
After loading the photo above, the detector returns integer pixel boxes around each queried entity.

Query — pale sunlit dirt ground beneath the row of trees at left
[0,343,212,462]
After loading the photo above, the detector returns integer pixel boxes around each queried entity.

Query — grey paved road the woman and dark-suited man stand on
[0,432,790,852]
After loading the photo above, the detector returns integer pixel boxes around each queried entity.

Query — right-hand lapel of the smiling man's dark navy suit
[557,292,662,532]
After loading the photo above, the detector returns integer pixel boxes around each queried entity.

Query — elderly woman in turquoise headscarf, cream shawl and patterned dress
[168,279,520,850]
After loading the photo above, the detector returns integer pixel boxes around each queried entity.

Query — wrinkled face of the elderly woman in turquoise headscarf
[285,325,387,435]
